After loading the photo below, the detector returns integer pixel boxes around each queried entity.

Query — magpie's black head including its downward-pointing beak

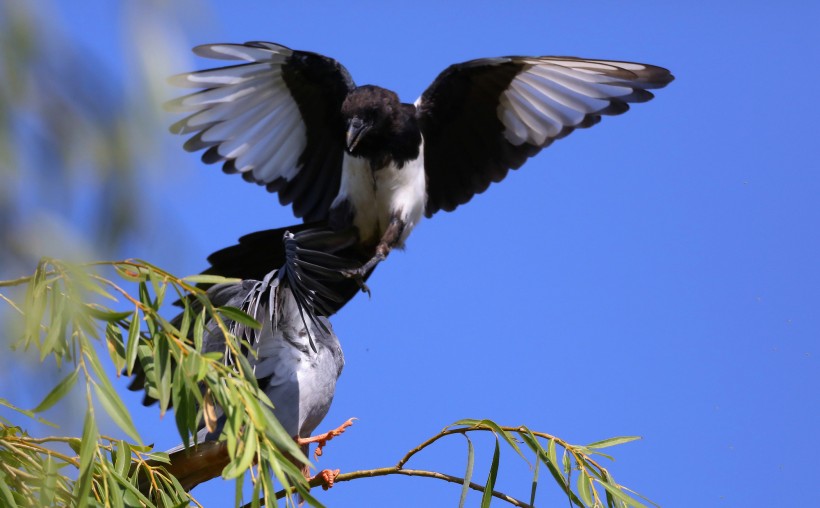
[342,85,401,156]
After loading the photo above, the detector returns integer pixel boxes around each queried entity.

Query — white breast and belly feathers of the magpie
[333,139,427,247]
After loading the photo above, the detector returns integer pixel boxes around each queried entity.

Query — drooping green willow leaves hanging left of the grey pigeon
[0,259,313,506]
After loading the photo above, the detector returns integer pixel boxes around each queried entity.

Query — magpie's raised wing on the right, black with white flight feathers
[416,57,673,217]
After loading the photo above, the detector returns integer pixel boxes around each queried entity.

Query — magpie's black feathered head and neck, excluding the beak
[342,85,421,171]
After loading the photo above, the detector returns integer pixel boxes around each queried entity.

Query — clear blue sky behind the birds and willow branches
[8,1,820,507]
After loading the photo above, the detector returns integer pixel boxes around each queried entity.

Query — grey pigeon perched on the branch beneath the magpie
[130,233,352,489]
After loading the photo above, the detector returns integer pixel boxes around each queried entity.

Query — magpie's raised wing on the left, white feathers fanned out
[167,42,355,221]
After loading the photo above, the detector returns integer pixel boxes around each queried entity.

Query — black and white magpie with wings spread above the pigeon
[168,42,673,289]
